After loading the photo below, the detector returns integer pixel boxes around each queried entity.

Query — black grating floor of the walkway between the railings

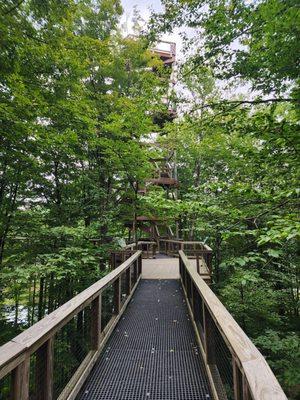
[77,280,212,400]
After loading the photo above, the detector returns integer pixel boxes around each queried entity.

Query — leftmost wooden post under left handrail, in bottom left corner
[11,357,30,400]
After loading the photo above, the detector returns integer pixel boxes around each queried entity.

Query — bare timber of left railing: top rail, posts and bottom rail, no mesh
[0,251,142,400]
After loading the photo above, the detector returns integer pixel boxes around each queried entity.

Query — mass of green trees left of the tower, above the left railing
[0,0,168,341]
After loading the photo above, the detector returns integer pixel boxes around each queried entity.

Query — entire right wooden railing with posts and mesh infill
[179,251,287,400]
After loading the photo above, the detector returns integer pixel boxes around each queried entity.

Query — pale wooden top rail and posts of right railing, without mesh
[179,251,287,400]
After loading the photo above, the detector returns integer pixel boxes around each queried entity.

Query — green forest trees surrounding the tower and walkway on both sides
[0,0,300,399]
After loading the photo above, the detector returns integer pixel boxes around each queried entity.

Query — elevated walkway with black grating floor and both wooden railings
[0,250,287,400]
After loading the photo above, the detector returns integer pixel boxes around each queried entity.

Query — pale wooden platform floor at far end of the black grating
[142,255,210,281]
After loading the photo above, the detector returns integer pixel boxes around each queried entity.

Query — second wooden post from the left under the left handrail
[35,337,54,400]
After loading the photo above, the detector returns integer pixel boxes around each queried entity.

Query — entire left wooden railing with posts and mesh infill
[0,251,142,400]
